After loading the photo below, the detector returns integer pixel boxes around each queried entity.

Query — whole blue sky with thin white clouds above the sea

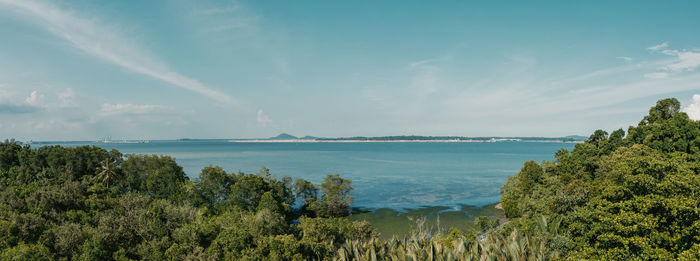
[0,0,700,140]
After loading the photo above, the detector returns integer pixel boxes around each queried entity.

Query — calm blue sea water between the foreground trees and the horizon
[39,140,574,209]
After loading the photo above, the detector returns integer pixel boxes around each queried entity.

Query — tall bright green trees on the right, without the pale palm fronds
[501,99,700,260]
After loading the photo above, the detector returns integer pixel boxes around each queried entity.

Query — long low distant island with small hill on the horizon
[229,133,588,142]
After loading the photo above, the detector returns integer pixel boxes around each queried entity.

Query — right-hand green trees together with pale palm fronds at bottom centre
[330,99,700,260]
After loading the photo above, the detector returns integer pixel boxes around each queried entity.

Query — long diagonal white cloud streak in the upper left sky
[0,0,236,104]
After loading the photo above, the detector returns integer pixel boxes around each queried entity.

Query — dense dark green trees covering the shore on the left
[0,141,376,260]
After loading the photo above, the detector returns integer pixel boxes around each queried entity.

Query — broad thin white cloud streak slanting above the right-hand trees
[448,43,700,122]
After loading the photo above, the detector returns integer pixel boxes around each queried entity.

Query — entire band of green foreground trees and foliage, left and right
[0,99,700,260]
